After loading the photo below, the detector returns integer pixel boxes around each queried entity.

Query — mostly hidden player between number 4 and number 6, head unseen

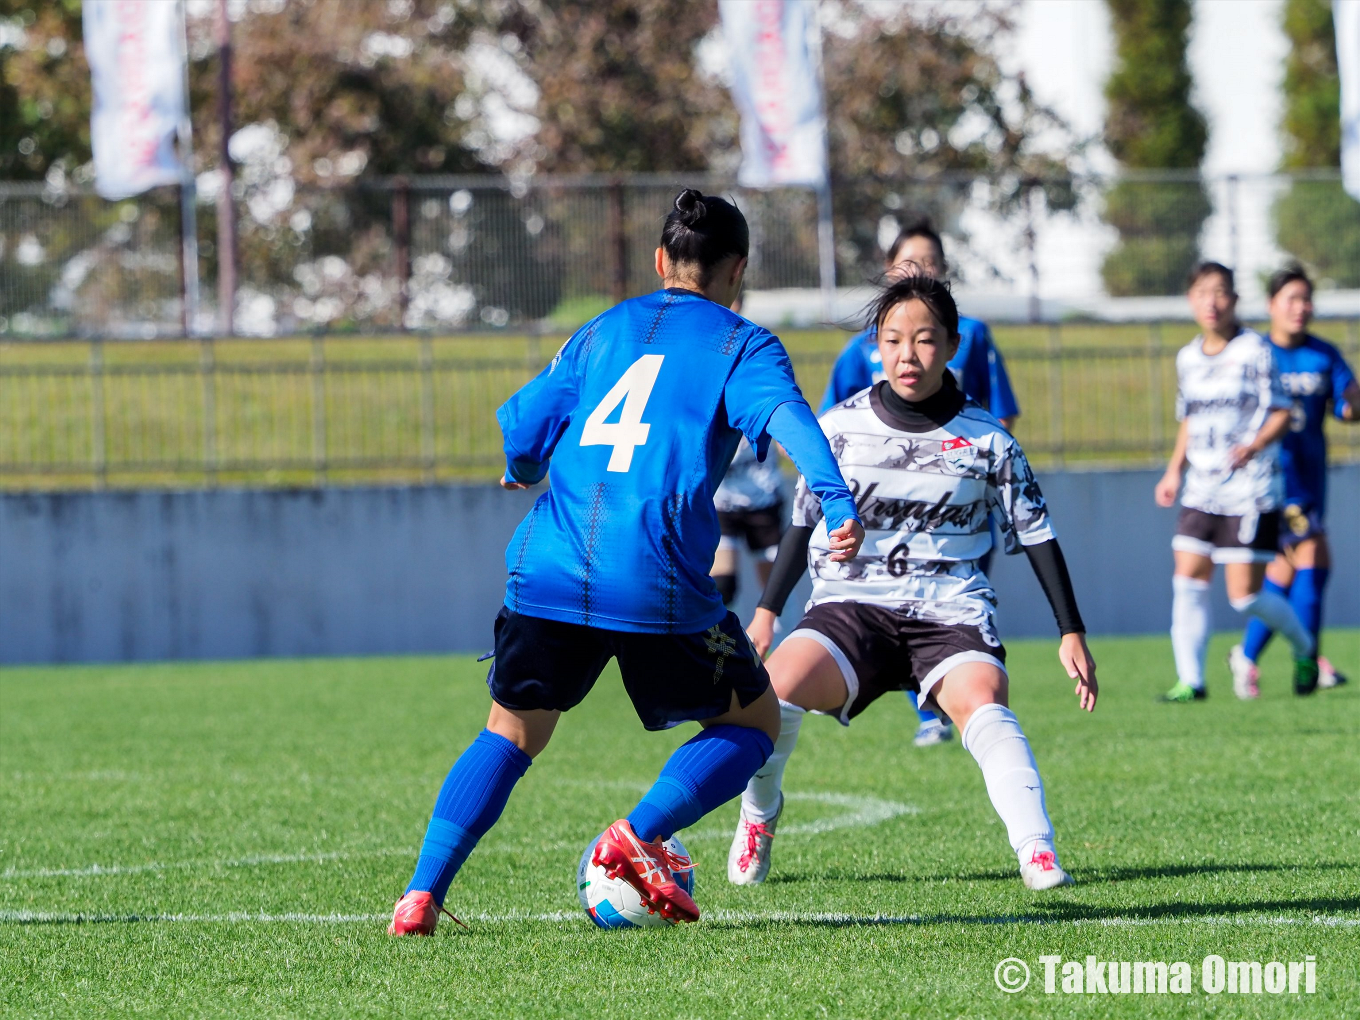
[710,439,783,605]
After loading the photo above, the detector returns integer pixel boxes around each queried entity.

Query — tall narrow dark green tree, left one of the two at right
[1100,0,1210,296]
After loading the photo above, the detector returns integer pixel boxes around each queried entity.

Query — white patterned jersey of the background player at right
[1176,329,1289,517]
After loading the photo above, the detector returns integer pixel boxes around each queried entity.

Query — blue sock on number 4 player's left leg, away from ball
[407,729,533,903]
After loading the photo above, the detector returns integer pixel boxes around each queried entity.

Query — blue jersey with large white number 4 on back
[496,290,802,634]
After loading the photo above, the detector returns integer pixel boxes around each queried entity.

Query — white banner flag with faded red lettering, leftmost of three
[83,0,185,200]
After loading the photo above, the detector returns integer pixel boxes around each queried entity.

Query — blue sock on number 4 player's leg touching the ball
[628,724,774,842]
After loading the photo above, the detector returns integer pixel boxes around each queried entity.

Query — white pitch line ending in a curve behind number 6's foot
[0,793,921,881]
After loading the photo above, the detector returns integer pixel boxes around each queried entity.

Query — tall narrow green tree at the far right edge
[1274,0,1360,287]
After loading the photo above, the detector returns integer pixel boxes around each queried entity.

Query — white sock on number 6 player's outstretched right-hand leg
[963,704,1053,865]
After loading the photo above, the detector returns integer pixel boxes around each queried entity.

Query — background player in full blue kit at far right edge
[1228,267,1360,698]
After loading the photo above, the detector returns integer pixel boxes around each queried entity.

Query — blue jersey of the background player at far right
[1270,336,1355,511]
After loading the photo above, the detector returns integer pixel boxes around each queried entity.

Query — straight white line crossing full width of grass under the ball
[0,910,1360,928]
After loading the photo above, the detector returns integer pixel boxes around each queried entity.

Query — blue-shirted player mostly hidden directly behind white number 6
[821,219,1020,747]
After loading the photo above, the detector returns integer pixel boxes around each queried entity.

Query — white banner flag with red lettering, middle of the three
[718,0,827,188]
